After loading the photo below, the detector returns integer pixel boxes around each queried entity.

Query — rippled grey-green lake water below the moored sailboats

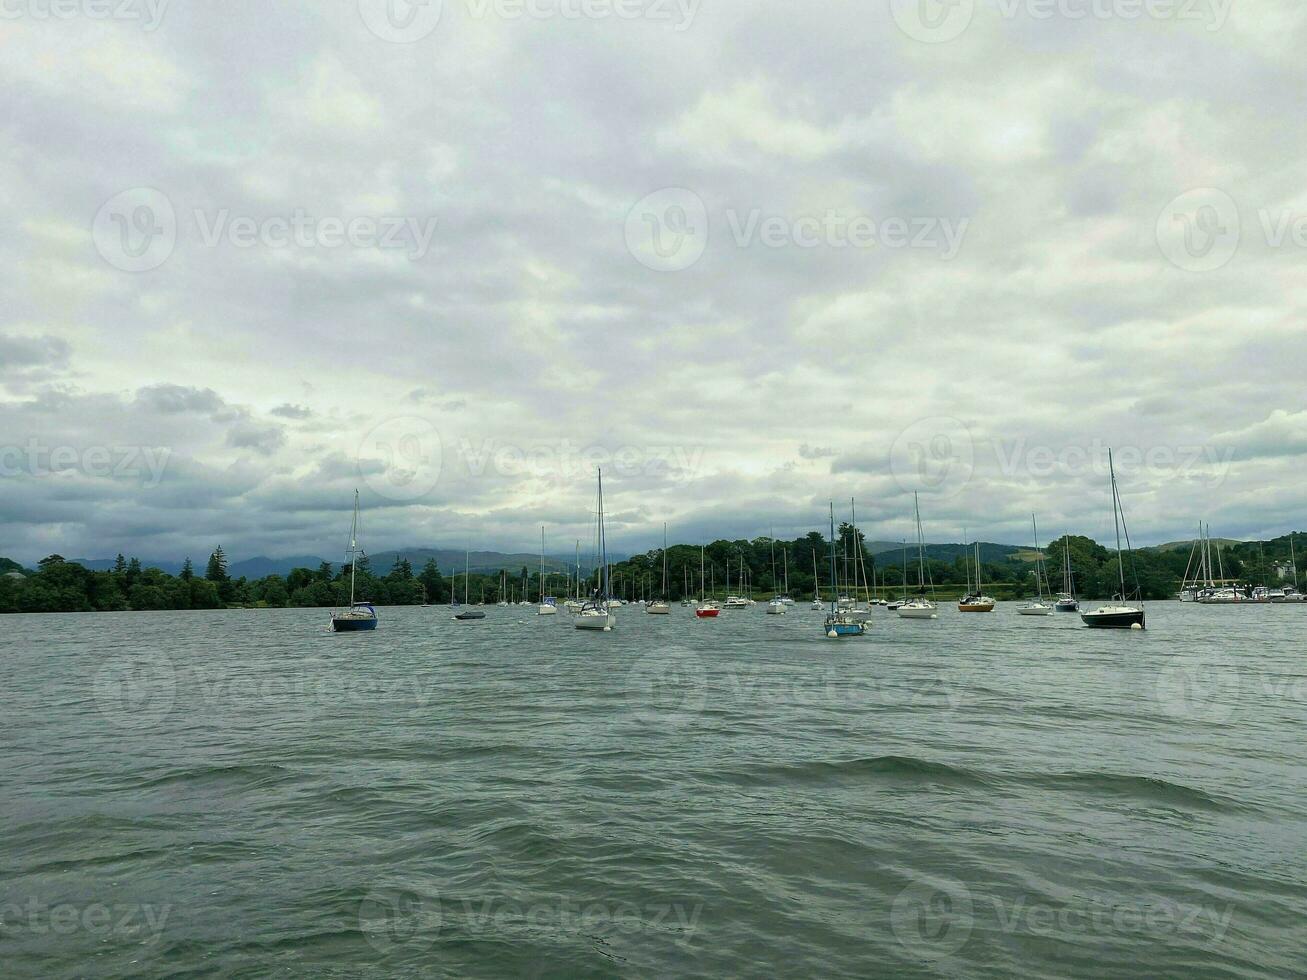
[0,604,1307,977]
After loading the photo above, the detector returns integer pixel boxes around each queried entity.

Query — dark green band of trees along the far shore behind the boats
[0,524,1293,613]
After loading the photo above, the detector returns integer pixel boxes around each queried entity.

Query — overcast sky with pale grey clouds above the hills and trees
[0,0,1307,562]
